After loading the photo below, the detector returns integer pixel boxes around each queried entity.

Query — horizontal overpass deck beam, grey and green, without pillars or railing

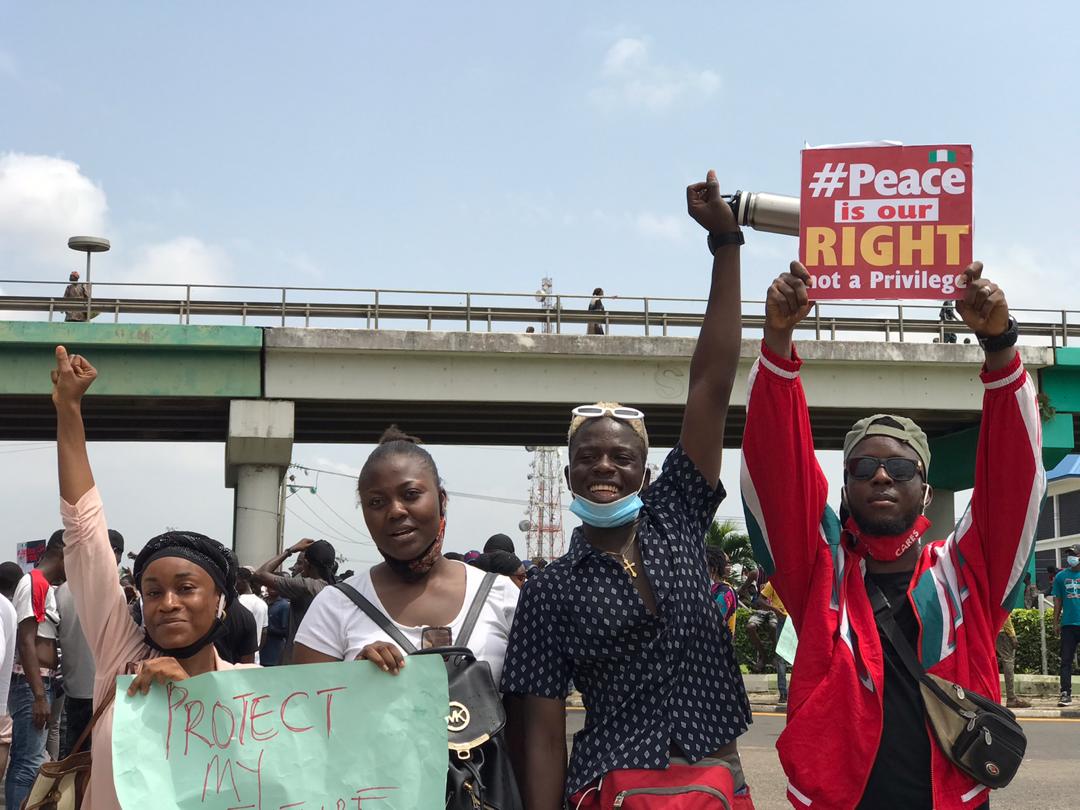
[0,322,1075,449]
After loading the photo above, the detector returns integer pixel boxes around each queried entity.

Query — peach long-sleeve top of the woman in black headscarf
[60,487,248,810]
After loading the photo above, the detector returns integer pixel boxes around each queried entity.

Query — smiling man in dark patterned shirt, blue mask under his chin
[502,172,753,810]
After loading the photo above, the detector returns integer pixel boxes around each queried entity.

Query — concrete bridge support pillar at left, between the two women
[225,400,294,565]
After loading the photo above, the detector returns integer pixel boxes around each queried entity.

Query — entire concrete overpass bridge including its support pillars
[0,285,1080,561]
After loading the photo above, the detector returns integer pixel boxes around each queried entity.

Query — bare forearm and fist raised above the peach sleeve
[52,346,97,503]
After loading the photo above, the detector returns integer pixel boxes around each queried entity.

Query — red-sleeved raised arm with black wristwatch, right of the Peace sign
[953,261,1047,621]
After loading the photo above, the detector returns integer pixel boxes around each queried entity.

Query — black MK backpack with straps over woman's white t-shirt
[334,573,524,810]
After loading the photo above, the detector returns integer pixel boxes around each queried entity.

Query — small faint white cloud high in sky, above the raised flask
[592,37,720,112]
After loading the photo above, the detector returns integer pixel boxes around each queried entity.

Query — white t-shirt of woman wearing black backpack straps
[296,561,521,684]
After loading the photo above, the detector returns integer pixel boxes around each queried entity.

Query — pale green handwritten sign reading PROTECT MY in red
[112,656,449,810]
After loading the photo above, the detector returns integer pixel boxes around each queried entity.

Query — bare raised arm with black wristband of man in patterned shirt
[679,170,742,487]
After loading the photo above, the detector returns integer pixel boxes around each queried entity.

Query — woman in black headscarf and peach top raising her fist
[52,347,254,810]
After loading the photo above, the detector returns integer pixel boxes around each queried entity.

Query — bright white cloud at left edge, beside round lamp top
[0,152,108,274]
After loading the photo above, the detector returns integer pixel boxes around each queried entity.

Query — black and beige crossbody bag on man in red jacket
[866,580,1027,788]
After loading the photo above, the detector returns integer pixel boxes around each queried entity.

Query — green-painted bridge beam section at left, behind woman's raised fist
[0,321,262,399]
